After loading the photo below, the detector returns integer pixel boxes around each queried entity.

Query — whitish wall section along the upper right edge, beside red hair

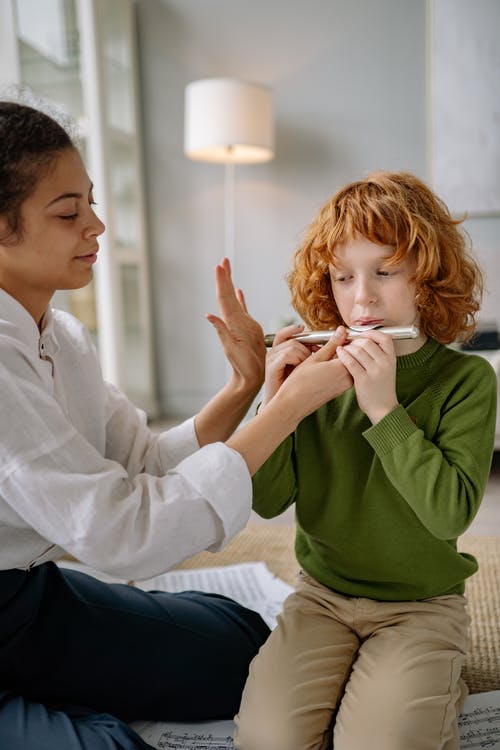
[428,0,500,332]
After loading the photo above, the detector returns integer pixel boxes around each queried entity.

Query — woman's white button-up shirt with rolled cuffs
[0,289,252,579]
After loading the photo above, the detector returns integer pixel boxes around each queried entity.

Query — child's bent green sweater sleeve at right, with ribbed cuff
[364,355,497,539]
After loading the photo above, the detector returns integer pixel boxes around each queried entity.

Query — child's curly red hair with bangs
[287,172,483,344]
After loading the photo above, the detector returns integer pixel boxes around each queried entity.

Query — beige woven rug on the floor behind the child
[179,524,500,693]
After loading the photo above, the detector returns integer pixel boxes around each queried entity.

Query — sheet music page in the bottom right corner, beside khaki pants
[458,690,500,750]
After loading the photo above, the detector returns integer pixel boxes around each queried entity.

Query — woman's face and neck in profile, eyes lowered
[0,148,104,322]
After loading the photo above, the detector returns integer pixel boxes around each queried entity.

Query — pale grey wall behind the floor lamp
[137,0,494,416]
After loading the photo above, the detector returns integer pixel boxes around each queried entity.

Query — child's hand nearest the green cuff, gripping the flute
[337,330,398,424]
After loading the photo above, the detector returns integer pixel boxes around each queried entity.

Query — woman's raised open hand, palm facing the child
[206,258,266,394]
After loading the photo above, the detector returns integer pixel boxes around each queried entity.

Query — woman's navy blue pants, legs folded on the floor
[0,563,269,750]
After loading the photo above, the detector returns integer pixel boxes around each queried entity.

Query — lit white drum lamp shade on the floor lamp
[184,78,274,164]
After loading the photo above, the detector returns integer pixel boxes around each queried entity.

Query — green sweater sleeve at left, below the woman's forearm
[252,435,297,518]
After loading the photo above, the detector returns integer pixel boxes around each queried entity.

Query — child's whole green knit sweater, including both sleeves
[253,339,497,601]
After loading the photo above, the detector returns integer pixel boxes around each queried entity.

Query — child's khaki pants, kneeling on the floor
[235,573,469,750]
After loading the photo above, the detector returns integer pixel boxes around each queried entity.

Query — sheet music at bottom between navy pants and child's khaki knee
[130,720,234,750]
